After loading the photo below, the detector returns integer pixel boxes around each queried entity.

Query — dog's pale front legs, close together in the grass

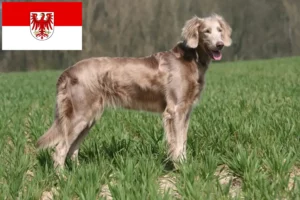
[163,103,191,161]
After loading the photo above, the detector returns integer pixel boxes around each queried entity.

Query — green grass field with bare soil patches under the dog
[0,57,300,200]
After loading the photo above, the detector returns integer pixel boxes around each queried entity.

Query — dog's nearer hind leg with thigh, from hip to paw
[53,72,104,168]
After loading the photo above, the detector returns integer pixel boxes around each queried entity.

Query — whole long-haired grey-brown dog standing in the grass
[37,14,231,167]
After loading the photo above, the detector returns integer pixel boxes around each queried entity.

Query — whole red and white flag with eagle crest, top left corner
[2,2,82,50]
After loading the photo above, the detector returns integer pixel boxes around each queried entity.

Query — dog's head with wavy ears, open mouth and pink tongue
[182,14,232,60]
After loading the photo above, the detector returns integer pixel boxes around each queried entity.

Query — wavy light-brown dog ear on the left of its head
[181,16,202,48]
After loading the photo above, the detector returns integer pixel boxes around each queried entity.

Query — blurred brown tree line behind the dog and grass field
[0,0,300,71]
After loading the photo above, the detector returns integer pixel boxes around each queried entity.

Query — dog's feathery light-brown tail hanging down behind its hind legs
[36,73,73,149]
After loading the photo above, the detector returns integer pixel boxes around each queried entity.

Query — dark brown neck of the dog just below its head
[172,42,211,68]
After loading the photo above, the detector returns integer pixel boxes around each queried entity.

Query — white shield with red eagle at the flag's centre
[30,12,54,40]
